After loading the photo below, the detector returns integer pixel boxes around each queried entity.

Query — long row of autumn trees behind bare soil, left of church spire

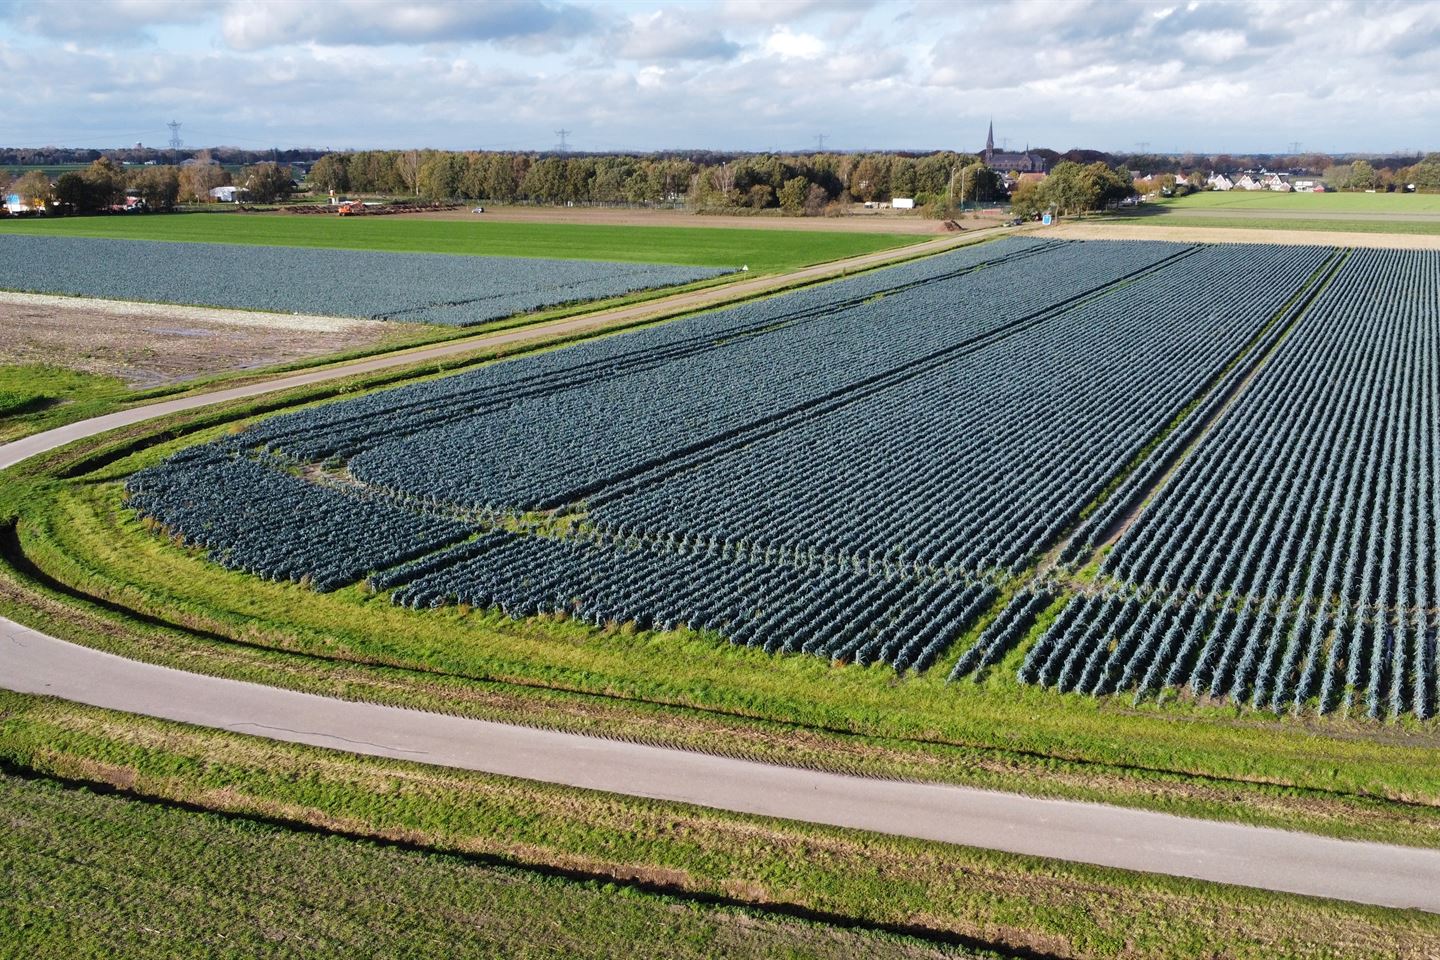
[308,150,1004,214]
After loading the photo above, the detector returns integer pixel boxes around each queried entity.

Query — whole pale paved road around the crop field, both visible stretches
[0,230,1440,913]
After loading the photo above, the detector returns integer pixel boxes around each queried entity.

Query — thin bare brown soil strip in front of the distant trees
[399,204,973,236]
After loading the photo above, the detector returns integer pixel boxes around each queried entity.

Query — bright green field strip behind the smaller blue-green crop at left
[0,213,929,273]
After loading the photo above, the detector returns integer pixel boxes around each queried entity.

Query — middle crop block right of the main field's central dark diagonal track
[590,248,1325,577]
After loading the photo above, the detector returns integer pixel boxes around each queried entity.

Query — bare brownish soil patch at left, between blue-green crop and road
[0,292,431,389]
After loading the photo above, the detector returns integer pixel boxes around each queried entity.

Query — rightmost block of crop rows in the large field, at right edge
[1022,250,1440,717]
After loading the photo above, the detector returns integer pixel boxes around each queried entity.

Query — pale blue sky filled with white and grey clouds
[0,0,1440,153]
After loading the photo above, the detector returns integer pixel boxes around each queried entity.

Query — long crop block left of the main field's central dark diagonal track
[342,243,1184,511]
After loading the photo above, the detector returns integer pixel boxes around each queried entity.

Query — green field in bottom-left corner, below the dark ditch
[0,773,972,960]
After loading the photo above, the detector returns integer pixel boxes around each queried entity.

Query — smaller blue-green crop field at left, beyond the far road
[0,236,730,327]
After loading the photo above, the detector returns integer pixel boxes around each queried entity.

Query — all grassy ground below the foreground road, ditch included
[0,692,1440,960]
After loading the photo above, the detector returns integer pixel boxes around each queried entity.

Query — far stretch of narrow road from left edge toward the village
[0,227,984,469]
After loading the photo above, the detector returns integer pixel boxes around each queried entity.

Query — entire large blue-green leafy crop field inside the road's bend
[128,237,1440,717]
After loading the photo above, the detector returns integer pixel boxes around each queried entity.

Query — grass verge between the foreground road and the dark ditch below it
[0,694,1440,959]
